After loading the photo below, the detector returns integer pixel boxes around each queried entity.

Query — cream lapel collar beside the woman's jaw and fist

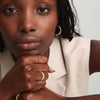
[48,38,66,79]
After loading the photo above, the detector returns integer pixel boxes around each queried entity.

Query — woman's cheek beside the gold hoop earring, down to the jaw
[38,19,57,53]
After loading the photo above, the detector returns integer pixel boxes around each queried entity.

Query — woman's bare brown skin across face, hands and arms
[0,0,100,100]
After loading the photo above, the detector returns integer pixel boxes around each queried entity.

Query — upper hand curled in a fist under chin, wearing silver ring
[0,55,52,99]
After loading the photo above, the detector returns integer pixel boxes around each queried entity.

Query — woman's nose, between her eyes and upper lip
[18,13,36,33]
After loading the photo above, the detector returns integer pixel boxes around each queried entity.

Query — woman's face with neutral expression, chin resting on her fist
[0,0,58,57]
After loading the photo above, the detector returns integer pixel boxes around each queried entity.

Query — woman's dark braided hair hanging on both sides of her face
[0,0,80,52]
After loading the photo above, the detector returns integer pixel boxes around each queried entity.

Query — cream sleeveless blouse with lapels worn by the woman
[0,37,90,97]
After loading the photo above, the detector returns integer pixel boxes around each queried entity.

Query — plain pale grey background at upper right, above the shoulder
[73,0,100,40]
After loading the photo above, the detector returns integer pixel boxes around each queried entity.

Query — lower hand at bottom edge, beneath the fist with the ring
[14,87,63,100]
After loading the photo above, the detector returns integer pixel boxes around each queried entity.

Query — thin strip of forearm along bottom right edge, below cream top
[61,95,100,100]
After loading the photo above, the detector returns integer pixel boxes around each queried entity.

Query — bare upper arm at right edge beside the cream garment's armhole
[89,40,100,74]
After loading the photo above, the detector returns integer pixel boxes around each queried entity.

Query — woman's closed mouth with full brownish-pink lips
[15,37,41,51]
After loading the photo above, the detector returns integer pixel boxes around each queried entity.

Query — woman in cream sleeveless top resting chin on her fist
[0,0,100,100]
